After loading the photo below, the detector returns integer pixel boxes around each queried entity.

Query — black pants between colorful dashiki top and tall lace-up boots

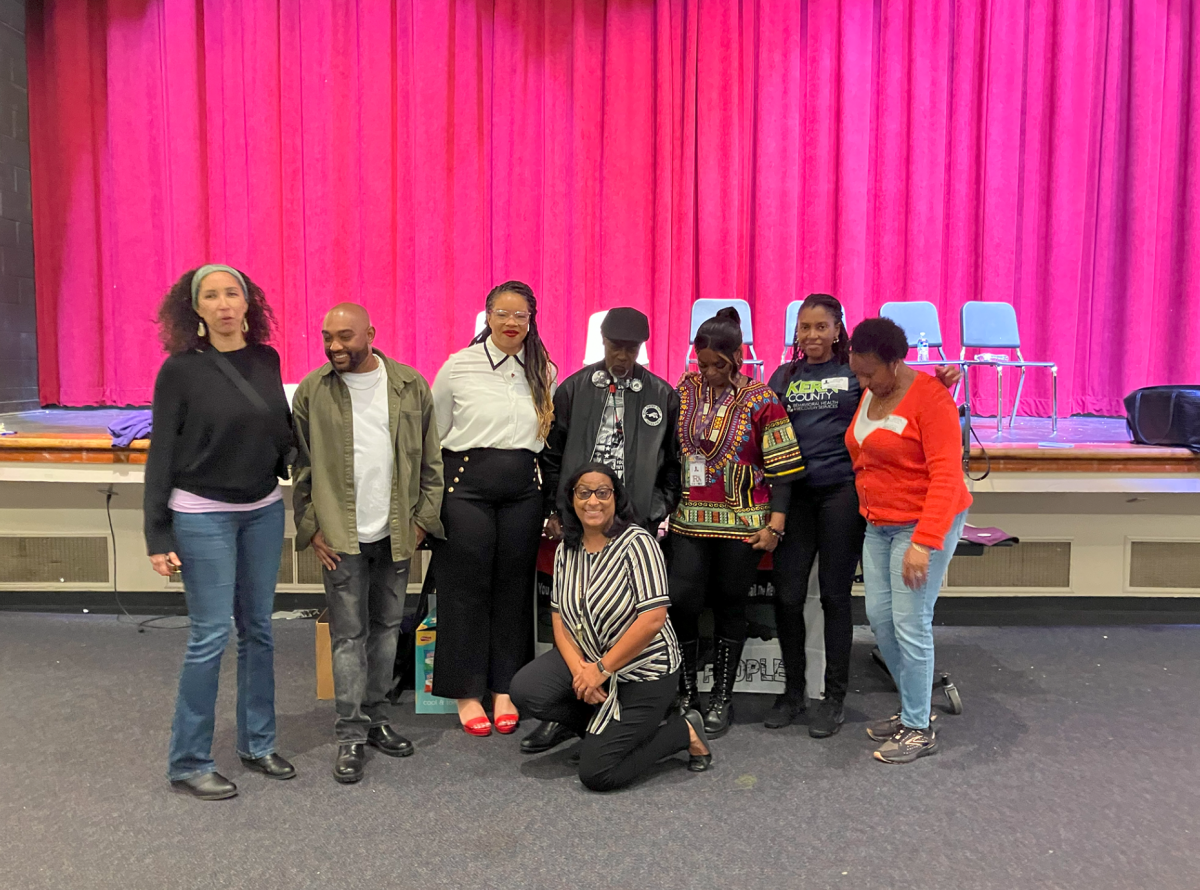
[667,531,762,643]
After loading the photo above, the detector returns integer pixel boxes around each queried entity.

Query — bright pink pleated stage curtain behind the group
[28,0,1200,414]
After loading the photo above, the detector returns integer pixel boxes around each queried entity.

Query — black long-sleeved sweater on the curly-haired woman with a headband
[143,345,292,554]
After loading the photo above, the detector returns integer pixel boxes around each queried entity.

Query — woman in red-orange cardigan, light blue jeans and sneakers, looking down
[846,318,971,763]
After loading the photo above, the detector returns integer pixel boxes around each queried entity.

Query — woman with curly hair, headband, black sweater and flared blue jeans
[144,265,295,800]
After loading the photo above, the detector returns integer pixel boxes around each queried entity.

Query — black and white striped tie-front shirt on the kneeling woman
[550,525,683,733]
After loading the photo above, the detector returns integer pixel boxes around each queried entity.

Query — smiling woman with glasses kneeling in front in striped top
[512,463,713,792]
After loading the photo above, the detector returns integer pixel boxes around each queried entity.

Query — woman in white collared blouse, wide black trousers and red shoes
[432,281,556,735]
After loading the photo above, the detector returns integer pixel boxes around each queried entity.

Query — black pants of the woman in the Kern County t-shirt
[774,481,866,702]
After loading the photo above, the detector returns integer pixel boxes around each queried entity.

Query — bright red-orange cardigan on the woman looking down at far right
[846,372,971,549]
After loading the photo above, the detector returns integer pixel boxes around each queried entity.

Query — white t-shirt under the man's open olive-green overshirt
[341,361,394,543]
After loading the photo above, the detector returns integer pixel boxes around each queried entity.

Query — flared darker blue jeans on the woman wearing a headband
[167,501,283,781]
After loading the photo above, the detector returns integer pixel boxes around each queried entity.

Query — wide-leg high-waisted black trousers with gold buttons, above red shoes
[431,449,542,698]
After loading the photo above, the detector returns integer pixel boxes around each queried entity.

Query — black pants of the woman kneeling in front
[512,649,689,792]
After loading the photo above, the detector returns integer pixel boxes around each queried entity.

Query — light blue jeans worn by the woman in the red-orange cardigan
[863,510,967,729]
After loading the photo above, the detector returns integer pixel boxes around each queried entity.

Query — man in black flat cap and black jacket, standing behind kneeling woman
[521,307,683,754]
